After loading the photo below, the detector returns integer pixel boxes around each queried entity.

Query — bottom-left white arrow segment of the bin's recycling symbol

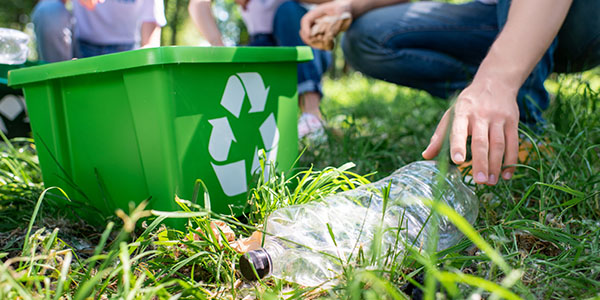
[210,160,248,197]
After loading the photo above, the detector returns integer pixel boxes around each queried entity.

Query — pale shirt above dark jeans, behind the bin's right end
[241,0,286,35]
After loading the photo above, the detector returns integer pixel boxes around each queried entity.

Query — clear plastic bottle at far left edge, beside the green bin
[0,28,29,65]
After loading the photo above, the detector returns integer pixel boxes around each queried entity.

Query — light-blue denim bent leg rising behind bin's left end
[32,0,73,62]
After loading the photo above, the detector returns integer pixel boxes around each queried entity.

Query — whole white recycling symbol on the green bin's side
[208,72,279,197]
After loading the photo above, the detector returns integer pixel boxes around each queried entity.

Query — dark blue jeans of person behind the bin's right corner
[249,1,331,95]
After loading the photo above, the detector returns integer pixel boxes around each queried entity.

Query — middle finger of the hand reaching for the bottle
[471,120,489,184]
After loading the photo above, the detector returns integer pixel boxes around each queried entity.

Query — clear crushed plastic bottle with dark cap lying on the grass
[240,161,479,286]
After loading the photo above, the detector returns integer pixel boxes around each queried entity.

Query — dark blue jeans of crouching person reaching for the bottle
[342,0,600,125]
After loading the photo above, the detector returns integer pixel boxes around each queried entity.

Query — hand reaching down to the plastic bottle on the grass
[423,80,519,185]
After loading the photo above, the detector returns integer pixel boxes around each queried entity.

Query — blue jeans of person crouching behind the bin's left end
[32,0,135,62]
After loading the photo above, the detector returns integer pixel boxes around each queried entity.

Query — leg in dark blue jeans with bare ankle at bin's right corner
[273,1,331,118]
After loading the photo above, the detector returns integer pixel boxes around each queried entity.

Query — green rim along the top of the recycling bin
[8,46,313,87]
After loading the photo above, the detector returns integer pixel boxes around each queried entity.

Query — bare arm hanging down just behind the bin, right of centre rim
[188,0,224,46]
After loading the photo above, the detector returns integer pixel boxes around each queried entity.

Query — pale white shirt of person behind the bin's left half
[72,0,167,45]
